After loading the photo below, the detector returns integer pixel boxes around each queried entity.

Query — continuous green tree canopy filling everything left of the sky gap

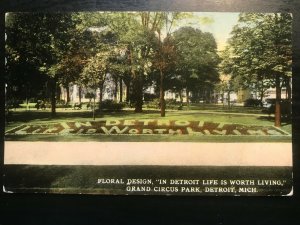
[6,12,220,116]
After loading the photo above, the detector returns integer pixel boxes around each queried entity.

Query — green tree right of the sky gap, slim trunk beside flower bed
[223,13,292,127]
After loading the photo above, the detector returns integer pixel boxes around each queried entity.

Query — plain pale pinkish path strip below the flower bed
[4,141,292,166]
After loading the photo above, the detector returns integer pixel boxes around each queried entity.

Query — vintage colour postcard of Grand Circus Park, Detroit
[3,11,293,196]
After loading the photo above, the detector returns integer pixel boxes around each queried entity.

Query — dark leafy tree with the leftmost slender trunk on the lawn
[7,13,76,116]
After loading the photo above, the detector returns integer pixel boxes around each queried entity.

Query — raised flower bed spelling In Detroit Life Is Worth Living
[5,119,289,136]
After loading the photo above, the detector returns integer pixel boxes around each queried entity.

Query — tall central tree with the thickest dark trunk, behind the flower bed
[106,12,163,112]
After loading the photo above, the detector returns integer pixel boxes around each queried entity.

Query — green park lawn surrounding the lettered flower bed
[6,107,291,142]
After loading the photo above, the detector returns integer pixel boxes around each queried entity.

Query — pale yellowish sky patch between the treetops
[178,12,239,51]
